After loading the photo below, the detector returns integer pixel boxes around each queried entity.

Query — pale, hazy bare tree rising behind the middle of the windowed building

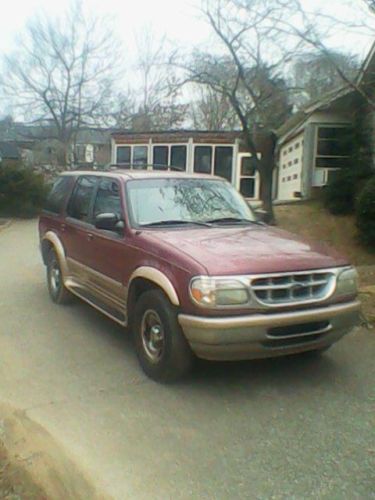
[115,28,187,131]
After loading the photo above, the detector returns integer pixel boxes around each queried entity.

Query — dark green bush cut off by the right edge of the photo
[356,175,375,248]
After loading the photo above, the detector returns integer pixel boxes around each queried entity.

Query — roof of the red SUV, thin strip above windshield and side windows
[61,169,225,181]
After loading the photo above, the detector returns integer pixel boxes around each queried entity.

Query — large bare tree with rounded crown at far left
[1,3,118,166]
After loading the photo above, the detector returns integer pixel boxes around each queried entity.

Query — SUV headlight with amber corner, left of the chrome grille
[190,276,249,307]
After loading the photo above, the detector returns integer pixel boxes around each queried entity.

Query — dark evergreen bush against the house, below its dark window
[323,169,370,215]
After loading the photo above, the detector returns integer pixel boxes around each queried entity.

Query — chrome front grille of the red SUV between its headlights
[250,271,336,305]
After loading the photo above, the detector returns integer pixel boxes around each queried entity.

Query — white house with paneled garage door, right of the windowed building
[275,43,375,201]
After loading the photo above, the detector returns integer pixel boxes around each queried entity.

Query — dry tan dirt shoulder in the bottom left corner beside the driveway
[0,404,106,500]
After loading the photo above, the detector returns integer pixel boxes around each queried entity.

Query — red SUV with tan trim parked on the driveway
[39,171,360,381]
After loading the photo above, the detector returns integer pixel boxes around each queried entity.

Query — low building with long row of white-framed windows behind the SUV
[111,130,262,202]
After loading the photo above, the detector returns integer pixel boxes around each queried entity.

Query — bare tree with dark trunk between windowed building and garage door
[181,0,301,222]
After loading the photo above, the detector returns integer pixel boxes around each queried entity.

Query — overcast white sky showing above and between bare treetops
[0,0,375,115]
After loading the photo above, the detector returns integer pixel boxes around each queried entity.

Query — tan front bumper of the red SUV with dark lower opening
[178,301,360,360]
